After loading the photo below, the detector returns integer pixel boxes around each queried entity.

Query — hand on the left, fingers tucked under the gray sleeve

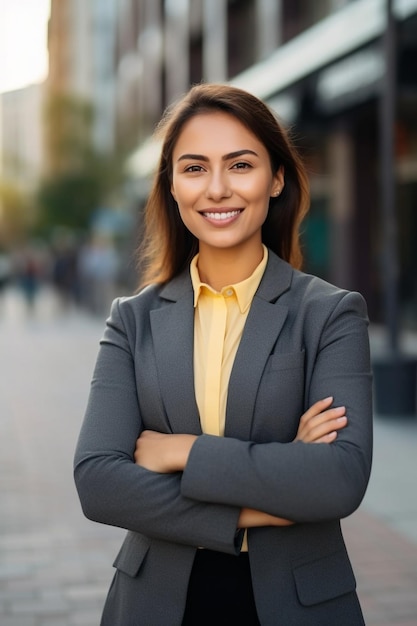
[134,430,197,474]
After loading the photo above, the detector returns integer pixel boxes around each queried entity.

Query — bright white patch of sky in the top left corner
[0,0,50,93]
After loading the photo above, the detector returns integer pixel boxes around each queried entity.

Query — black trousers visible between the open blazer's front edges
[182,550,260,626]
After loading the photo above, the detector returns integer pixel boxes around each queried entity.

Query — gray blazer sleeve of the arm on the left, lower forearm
[74,301,242,553]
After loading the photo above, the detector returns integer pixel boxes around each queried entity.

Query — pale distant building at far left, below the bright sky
[0,84,44,192]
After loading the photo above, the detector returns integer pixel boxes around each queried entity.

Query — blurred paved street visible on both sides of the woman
[0,290,417,626]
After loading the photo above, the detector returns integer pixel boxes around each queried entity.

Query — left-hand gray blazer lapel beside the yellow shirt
[150,276,201,435]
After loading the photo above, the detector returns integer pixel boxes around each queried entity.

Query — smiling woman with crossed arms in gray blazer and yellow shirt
[75,85,372,626]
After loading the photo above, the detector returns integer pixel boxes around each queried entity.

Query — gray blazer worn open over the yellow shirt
[75,252,372,626]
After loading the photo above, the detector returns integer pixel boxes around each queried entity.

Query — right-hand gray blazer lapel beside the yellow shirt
[225,252,293,439]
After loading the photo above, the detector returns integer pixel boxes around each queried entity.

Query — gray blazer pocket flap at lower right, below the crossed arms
[293,550,356,606]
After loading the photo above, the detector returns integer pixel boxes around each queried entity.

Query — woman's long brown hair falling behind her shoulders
[138,84,309,286]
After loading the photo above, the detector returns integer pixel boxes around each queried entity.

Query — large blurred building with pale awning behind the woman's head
[123,0,417,326]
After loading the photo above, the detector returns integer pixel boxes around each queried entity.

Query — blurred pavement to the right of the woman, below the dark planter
[342,417,417,626]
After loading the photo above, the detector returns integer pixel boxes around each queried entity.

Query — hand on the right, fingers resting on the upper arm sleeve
[294,396,347,443]
